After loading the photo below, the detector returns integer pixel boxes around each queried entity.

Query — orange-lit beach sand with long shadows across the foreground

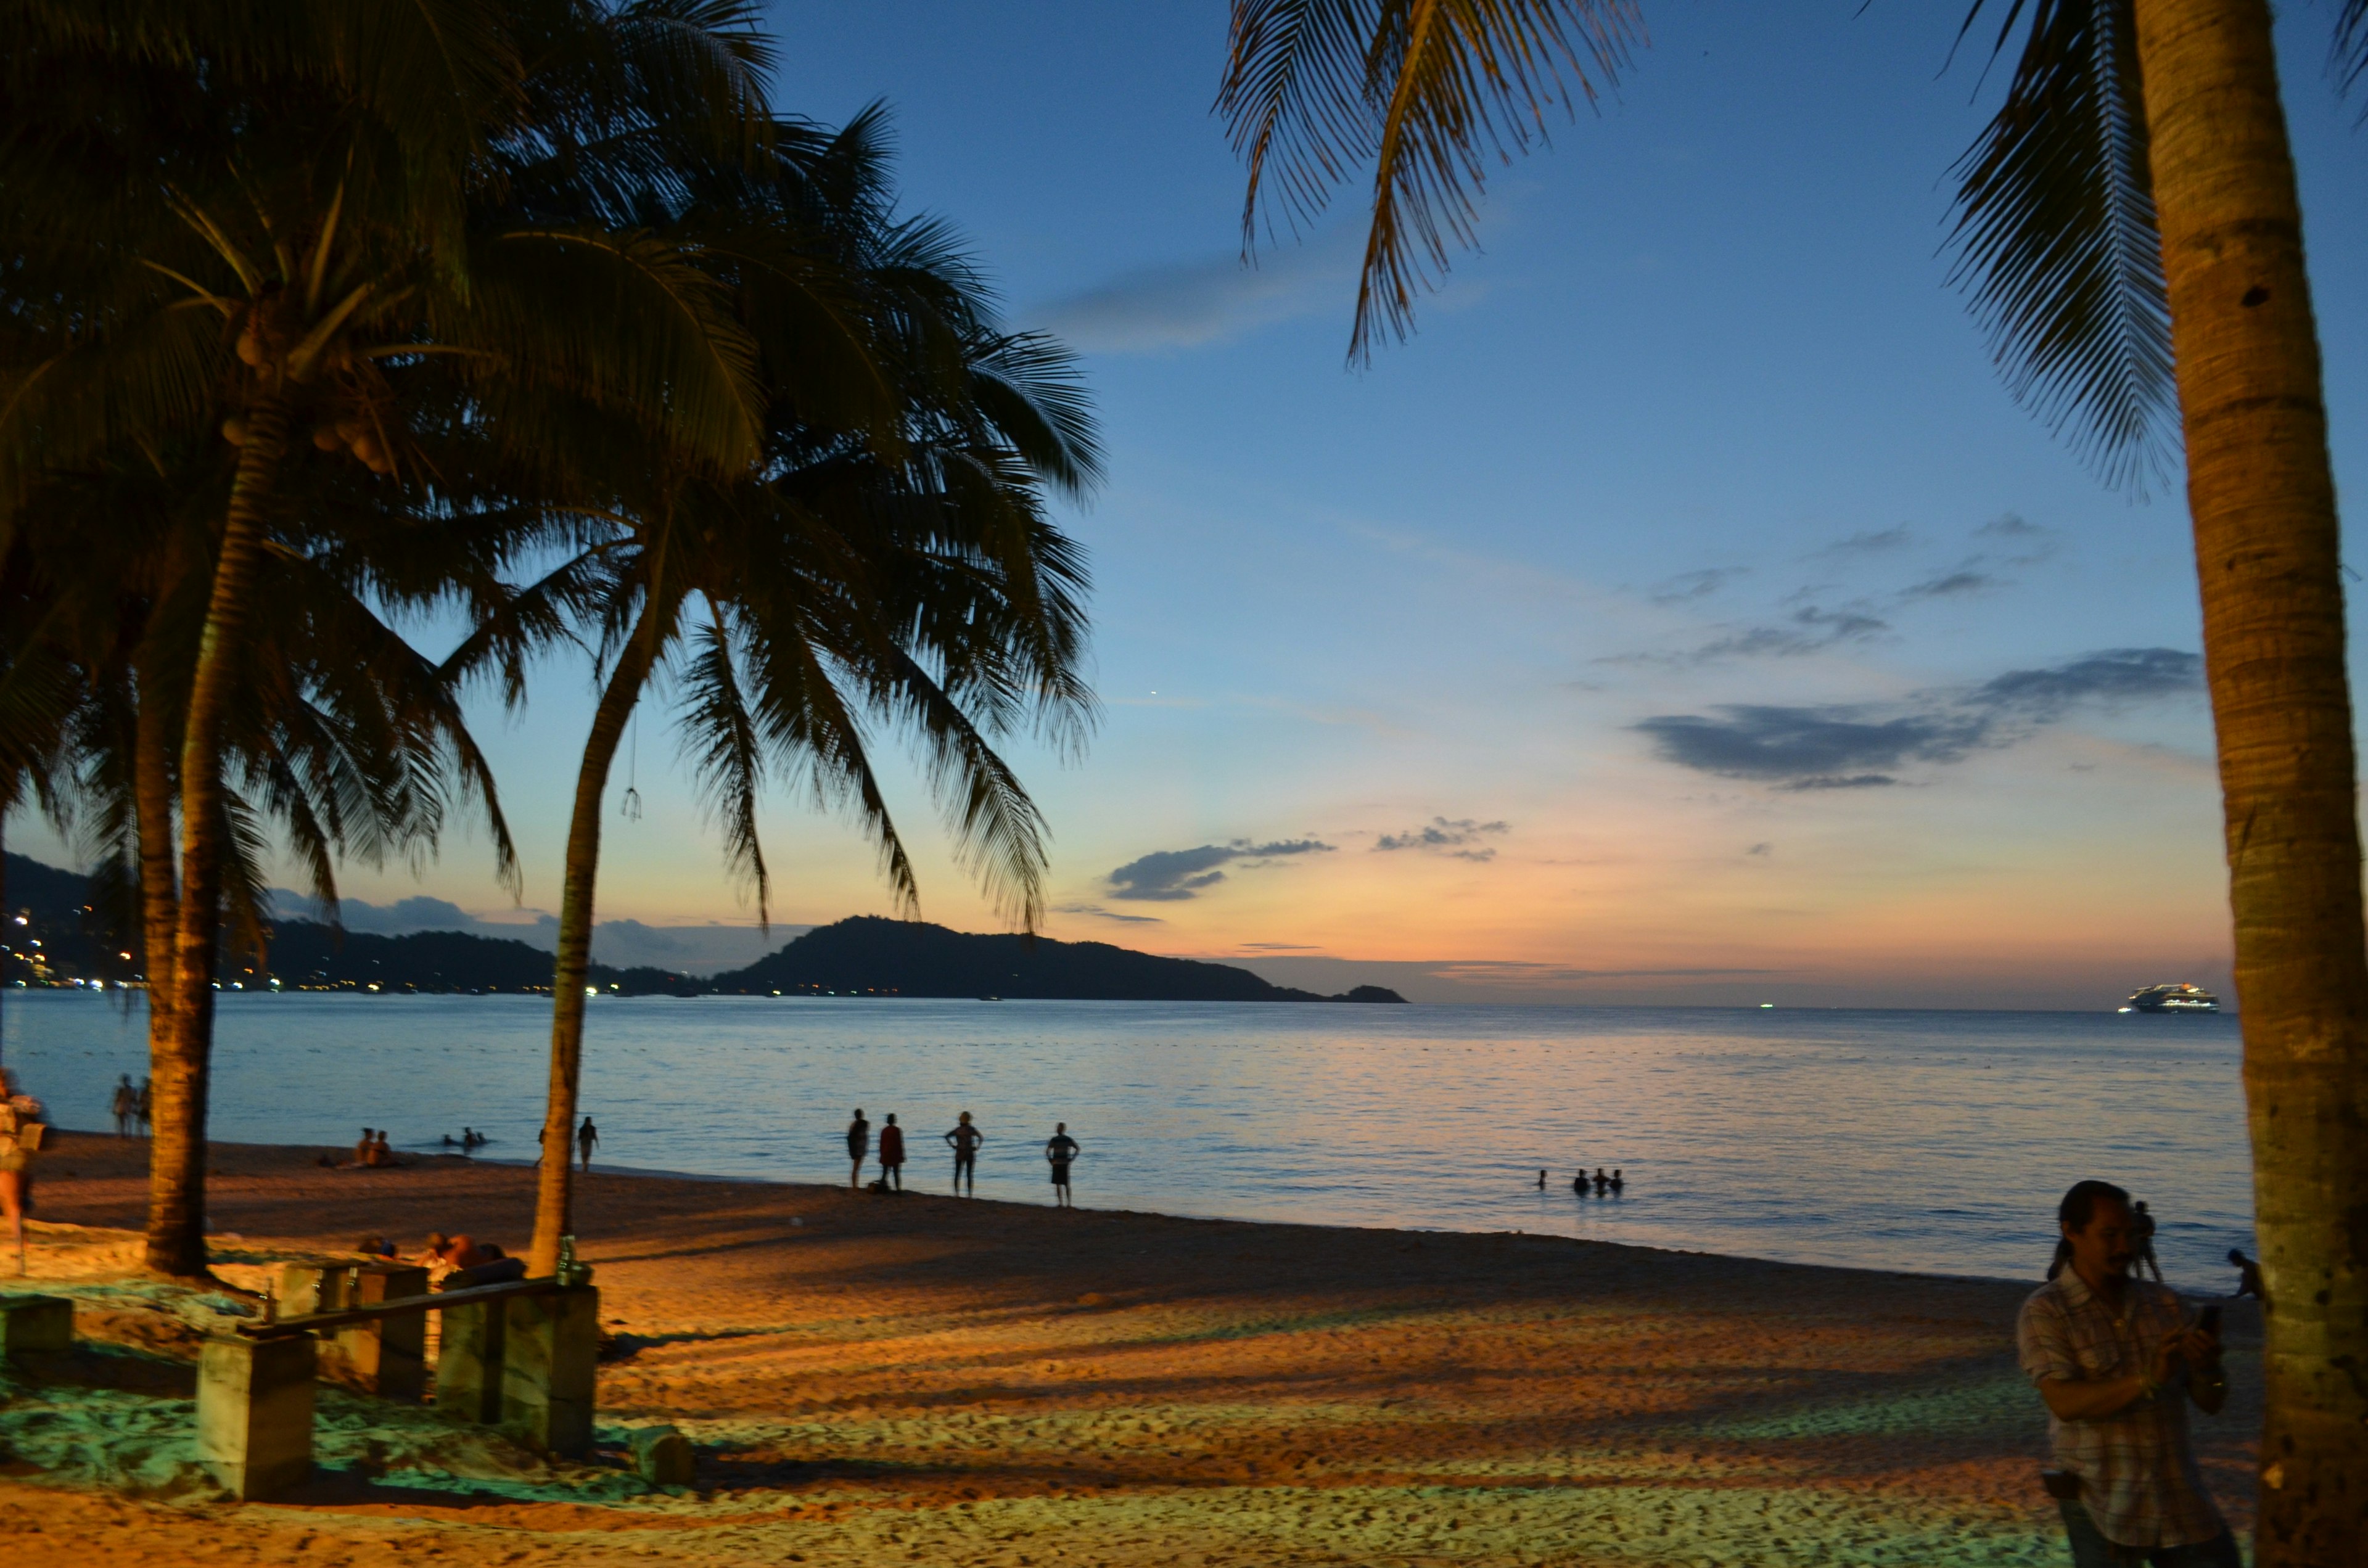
[0,1135,2259,1568]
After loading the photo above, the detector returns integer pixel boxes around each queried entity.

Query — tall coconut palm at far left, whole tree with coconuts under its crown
[0,0,796,1270]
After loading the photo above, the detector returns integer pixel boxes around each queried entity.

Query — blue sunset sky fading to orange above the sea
[19,0,2368,1007]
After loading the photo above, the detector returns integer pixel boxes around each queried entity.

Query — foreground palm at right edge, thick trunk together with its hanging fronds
[1220,0,2368,1568]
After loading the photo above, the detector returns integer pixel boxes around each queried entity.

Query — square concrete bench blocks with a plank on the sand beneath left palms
[197,1265,599,1500]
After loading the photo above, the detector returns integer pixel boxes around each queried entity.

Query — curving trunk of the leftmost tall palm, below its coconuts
[147,400,289,1277]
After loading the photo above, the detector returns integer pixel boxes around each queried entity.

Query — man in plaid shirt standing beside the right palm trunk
[2015,1182,2238,1568]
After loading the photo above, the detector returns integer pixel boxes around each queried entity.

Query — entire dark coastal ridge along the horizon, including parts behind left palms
[0,853,1404,1002]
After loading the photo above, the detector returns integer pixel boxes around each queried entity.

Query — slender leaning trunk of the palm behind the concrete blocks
[525,606,659,1277]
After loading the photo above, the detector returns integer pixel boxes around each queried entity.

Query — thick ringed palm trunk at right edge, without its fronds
[2136,0,2368,1568]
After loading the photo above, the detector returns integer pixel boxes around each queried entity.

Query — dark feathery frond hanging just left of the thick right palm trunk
[1949,0,2179,490]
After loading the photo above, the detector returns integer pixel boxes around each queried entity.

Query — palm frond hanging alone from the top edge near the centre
[1217,0,1643,363]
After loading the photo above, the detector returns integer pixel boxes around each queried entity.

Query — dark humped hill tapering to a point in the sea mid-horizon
[705,914,1404,1002]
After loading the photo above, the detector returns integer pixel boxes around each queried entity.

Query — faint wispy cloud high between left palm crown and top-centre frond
[1030,225,1357,353]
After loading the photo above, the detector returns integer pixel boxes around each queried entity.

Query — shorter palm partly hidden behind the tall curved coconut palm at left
[0,445,514,1275]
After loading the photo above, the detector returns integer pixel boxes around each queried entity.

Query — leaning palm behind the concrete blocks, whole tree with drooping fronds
[457,113,1099,1272]
